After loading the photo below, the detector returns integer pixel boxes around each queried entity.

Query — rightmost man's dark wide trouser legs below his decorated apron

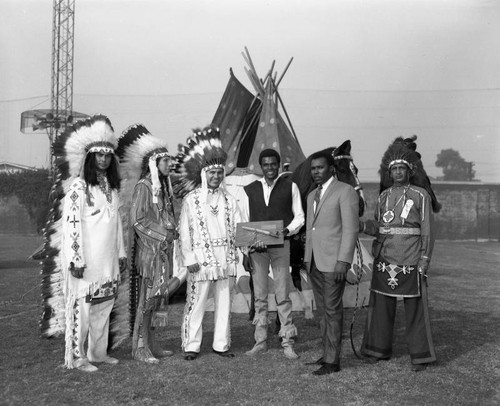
[361,292,436,364]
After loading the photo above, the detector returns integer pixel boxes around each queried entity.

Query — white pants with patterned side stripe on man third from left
[181,276,235,353]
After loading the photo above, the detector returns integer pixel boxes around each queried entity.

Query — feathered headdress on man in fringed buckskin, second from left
[117,124,170,203]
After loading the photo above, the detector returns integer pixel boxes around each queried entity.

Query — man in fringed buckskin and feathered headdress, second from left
[117,125,177,364]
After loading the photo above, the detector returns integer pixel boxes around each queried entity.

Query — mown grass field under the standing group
[0,235,500,405]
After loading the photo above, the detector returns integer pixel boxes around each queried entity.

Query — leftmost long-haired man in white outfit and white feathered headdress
[54,116,126,372]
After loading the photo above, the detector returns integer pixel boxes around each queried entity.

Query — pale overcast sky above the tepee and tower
[0,0,500,182]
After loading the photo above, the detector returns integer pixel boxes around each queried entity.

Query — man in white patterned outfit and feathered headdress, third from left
[174,127,241,361]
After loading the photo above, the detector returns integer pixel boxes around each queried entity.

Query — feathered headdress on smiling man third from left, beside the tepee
[174,126,227,198]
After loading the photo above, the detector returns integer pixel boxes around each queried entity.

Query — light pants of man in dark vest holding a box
[250,240,297,347]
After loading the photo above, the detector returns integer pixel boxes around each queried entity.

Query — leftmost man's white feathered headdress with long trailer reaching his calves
[40,115,117,337]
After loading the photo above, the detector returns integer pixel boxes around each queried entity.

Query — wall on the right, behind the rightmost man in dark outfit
[363,182,500,241]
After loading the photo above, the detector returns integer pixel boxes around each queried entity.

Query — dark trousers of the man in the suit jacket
[309,260,345,364]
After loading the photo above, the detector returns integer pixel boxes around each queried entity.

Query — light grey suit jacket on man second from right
[304,179,359,272]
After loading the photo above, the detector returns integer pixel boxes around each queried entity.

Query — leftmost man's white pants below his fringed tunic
[73,297,115,364]
